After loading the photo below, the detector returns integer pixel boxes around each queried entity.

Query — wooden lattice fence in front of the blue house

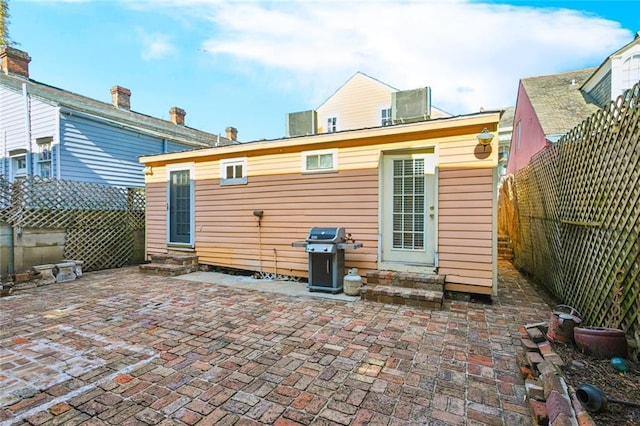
[0,176,145,271]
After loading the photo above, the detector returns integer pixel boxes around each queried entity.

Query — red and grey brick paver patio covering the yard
[0,262,551,426]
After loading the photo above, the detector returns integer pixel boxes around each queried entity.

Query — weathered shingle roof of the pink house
[520,67,599,135]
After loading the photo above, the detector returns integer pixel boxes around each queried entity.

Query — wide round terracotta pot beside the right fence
[573,327,627,359]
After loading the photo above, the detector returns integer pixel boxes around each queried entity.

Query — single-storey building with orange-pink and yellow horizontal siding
[140,111,500,294]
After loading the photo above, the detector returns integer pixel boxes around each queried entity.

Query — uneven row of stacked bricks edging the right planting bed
[518,323,595,426]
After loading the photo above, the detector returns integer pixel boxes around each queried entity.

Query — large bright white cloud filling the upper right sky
[129,0,632,113]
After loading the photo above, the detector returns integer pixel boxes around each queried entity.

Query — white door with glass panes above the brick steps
[382,154,436,266]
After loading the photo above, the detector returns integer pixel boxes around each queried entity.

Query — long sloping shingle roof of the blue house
[0,73,235,147]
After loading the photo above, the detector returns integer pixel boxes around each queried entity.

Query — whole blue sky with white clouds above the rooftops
[9,0,640,142]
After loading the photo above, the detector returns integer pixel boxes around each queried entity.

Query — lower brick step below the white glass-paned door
[361,284,444,310]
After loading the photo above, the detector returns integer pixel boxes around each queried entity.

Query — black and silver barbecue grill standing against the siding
[291,227,362,294]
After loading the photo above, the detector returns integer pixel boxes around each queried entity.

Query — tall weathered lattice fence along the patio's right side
[500,83,640,359]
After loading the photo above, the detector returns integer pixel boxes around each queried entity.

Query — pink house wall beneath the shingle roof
[507,83,549,174]
